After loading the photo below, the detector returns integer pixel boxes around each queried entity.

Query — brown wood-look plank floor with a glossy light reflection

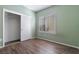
[0,39,79,54]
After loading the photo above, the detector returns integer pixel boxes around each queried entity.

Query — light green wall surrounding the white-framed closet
[0,5,35,45]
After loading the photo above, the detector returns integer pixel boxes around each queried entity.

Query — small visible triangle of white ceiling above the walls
[25,5,51,12]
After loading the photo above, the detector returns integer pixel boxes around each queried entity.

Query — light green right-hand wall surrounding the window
[36,5,79,47]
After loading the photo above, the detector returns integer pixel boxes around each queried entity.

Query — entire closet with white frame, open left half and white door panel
[3,9,32,47]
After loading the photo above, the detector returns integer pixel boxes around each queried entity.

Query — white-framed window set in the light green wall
[39,14,56,34]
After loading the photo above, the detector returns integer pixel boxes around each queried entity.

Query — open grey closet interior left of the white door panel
[4,11,21,45]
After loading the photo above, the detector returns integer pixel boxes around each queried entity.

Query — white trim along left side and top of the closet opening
[3,8,23,47]
